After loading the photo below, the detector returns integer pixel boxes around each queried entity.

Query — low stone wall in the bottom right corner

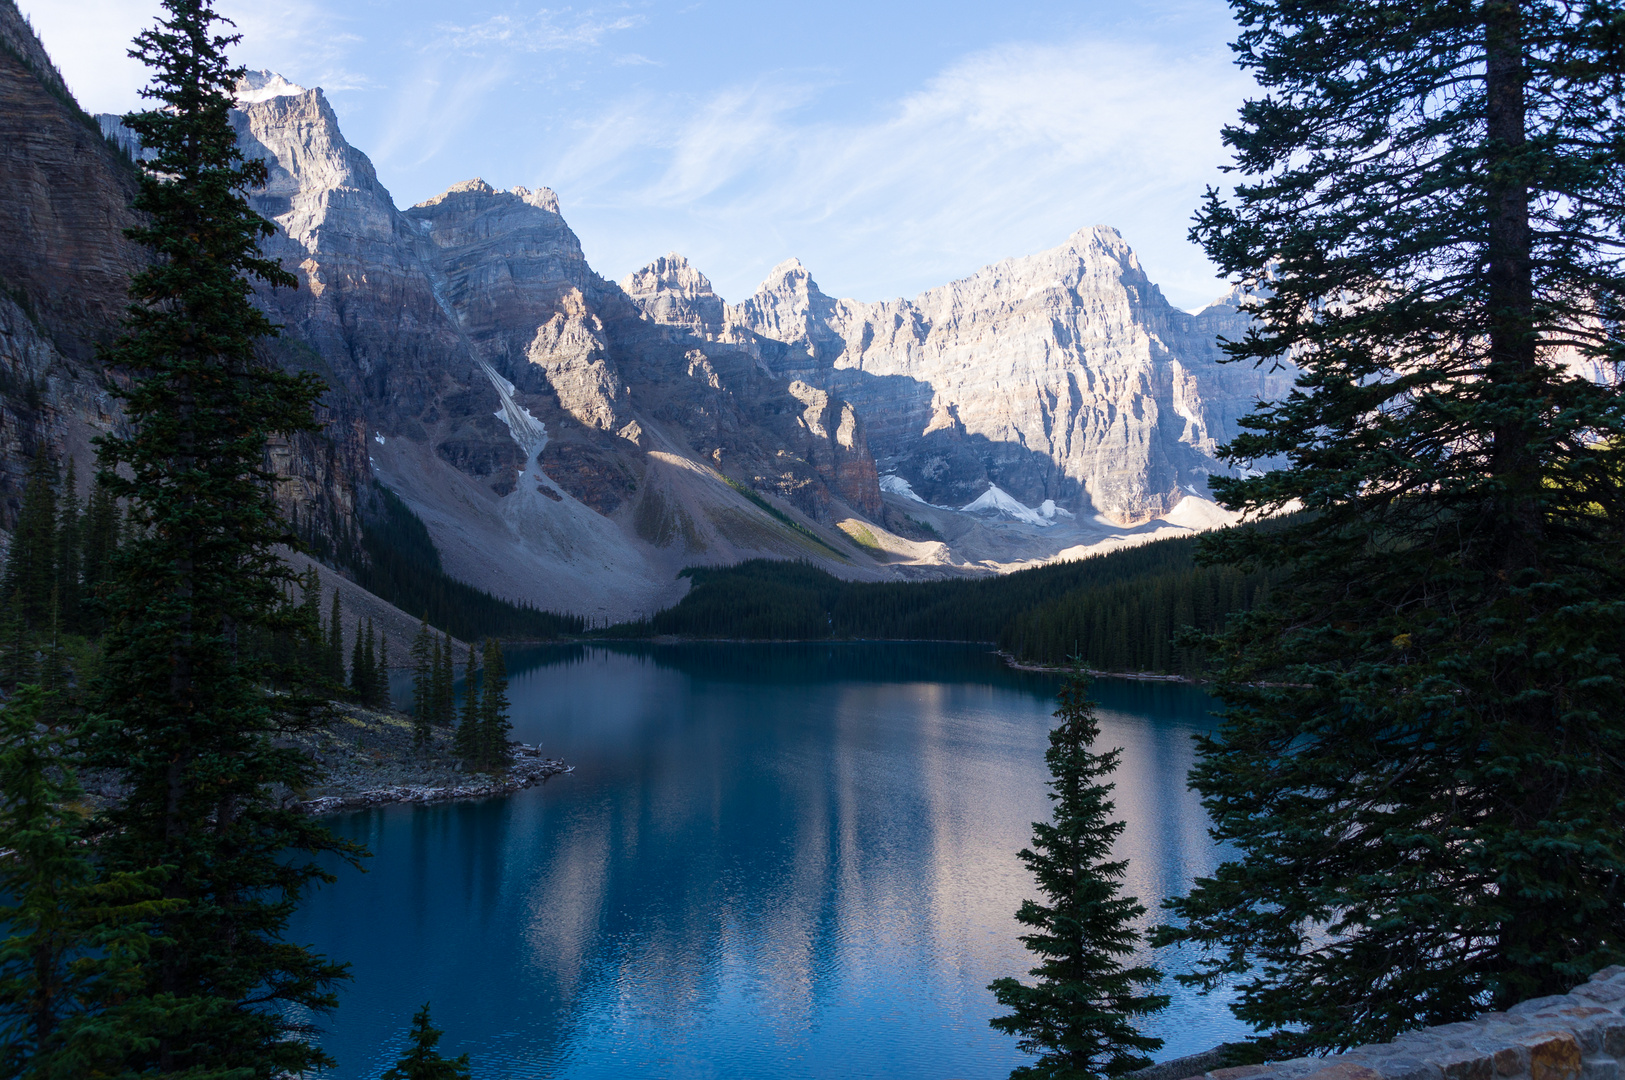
[1191,968,1625,1080]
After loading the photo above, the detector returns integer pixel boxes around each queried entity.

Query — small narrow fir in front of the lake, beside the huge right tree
[988,674,1168,1080]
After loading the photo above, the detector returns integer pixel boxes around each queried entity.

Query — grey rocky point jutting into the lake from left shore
[288,705,574,814]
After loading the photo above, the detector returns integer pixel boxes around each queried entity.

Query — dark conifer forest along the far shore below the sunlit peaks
[605,538,1279,674]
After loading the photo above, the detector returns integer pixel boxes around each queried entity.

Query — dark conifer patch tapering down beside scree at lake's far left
[351,487,587,642]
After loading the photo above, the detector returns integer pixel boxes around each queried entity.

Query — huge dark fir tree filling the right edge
[1167,0,1625,1052]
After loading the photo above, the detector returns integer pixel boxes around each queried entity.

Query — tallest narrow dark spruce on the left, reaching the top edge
[89,0,353,1080]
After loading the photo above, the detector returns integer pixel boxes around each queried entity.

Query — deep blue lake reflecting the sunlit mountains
[291,643,1245,1080]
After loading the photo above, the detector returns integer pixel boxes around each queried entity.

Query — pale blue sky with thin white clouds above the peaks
[20,0,1253,309]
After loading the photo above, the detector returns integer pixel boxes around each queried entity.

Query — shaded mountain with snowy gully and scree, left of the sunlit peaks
[217,73,882,617]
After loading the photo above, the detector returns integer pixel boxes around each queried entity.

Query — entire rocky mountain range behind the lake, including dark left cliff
[0,3,1281,620]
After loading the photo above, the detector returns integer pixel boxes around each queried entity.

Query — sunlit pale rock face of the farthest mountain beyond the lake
[646,227,1292,525]
